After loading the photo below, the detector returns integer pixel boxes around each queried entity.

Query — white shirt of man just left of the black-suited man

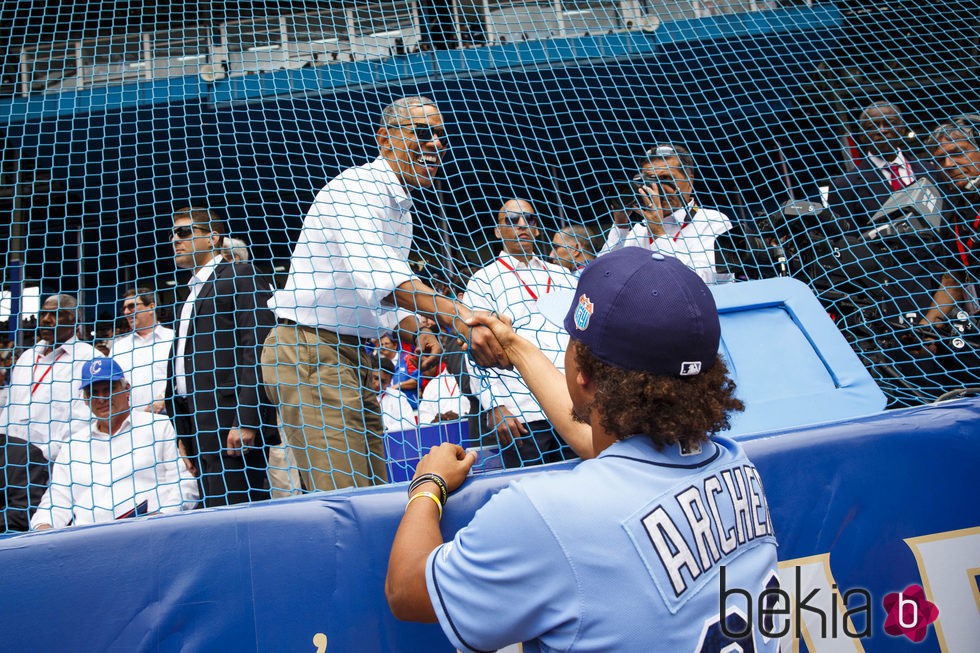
[109,324,174,410]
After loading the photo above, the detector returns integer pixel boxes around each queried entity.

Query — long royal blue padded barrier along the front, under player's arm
[0,399,980,653]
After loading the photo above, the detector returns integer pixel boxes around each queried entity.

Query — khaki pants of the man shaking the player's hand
[262,324,388,491]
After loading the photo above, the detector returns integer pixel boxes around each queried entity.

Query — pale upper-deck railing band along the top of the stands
[19,0,775,95]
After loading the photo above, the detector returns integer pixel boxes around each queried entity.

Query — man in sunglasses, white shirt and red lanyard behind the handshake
[464,199,575,467]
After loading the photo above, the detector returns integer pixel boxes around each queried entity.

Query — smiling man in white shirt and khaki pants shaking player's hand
[262,96,508,491]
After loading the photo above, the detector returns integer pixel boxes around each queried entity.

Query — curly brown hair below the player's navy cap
[570,342,745,450]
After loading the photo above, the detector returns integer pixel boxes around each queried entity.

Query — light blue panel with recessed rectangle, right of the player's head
[711,278,886,438]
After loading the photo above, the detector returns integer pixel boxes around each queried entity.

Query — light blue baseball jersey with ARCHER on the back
[426,436,778,653]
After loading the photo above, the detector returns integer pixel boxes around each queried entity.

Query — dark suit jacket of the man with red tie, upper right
[827,157,935,231]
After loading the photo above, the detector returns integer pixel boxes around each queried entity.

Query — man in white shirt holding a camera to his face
[599,145,732,283]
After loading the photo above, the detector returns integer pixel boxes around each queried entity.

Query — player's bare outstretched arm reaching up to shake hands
[467,312,595,459]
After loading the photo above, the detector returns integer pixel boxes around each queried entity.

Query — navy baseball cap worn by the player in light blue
[552,247,721,376]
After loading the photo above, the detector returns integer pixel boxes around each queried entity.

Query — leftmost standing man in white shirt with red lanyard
[0,295,99,531]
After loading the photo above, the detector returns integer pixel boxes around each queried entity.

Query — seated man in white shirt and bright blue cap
[31,358,200,530]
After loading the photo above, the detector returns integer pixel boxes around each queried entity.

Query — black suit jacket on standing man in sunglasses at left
[166,262,280,453]
